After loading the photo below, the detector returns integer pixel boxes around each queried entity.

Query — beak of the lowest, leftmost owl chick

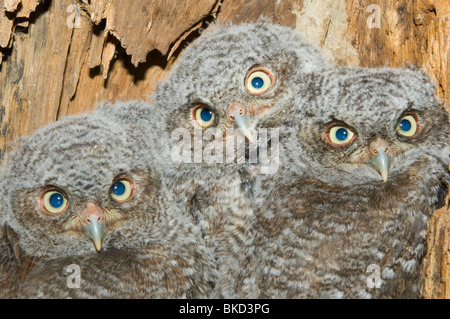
[81,203,106,251]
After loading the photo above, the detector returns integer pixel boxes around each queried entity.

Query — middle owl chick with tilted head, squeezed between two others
[94,23,328,296]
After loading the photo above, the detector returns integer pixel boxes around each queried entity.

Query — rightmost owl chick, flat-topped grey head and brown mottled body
[238,68,450,298]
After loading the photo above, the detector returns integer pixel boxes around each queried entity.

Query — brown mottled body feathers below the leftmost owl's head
[13,246,211,299]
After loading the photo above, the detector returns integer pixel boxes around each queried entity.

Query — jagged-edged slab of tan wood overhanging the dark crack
[88,0,217,66]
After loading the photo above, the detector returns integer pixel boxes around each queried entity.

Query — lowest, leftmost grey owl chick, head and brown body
[0,114,215,298]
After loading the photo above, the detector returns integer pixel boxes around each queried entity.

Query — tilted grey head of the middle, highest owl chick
[153,23,327,168]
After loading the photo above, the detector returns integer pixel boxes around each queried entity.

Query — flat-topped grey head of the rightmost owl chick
[258,68,449,185]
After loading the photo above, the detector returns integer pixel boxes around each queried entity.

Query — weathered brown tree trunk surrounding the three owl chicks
[0,0,450,298]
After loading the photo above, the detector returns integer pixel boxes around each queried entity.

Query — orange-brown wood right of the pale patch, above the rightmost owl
[347,0,450,105]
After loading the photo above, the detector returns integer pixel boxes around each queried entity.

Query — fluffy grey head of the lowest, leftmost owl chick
[2,114,181,257]
